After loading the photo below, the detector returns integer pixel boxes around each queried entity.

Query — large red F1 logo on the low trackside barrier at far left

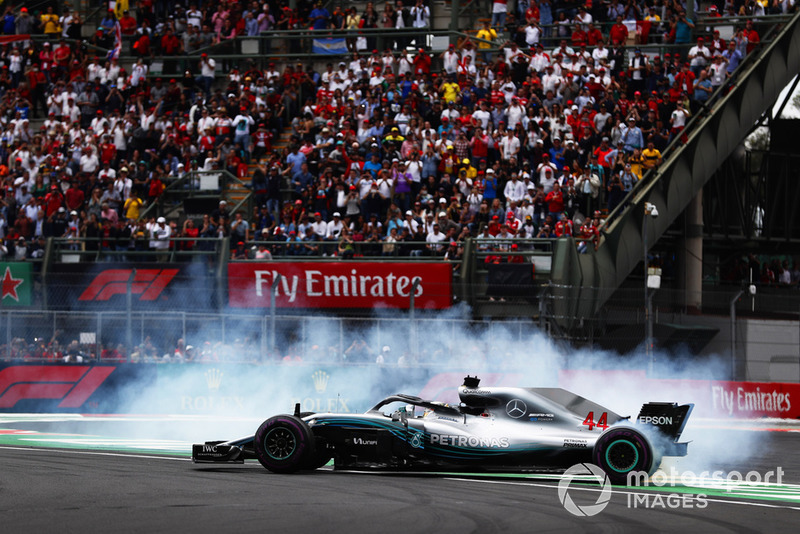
[0,365,116,408]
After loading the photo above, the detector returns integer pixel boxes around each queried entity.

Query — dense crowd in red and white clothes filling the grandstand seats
[0,0,793,260]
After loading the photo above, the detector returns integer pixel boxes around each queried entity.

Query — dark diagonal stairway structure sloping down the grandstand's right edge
[551,13,800,329]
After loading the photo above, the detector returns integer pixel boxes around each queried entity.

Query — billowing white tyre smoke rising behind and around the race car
[90,306,761,478]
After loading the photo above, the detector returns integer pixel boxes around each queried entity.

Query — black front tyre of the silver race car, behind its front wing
[253,415,315,473]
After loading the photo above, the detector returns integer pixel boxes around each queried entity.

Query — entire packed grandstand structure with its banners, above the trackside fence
[0,0,800,368]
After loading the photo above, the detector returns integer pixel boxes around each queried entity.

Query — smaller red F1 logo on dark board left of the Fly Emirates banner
[78,269,178,301]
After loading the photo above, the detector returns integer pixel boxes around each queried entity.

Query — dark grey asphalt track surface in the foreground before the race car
[0,431,800,534]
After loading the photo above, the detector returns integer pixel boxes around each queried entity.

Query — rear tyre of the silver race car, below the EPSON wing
[592,427,660,485]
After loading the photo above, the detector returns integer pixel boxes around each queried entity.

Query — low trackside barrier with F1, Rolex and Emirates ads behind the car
[0,363,800,419]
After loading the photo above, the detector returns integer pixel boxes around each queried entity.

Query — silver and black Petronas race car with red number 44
[192,376,694,484]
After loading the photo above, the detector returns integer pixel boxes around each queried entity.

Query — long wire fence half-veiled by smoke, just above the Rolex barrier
[0,311,538,364]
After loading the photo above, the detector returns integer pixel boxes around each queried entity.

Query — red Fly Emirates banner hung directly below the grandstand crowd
[228,262,452,309]
